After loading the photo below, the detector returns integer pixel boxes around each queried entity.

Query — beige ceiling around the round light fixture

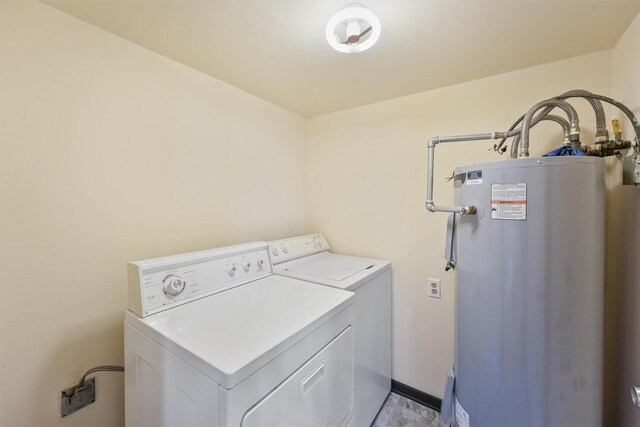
[42,0,640,117]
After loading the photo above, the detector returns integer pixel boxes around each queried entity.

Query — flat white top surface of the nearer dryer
[126,275,353,389]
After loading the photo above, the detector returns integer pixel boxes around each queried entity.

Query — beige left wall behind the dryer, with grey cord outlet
[0,1,305,427]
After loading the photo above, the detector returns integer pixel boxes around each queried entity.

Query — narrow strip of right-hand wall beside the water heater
[605,10,640,427]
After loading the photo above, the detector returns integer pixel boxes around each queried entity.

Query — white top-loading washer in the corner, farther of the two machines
[269,233,391,427]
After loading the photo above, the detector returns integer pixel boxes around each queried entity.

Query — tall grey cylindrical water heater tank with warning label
[455,157,605,427]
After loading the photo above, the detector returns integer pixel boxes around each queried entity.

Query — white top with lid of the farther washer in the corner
[273,251,391,291]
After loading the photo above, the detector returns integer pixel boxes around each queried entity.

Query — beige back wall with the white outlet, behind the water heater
[306,51,611,396]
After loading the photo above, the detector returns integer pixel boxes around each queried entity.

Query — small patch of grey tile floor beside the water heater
[371,393,449,427]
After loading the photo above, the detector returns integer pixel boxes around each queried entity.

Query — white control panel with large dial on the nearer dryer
[128,243,272,317]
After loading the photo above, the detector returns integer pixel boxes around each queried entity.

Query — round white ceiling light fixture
[325,4,380,53]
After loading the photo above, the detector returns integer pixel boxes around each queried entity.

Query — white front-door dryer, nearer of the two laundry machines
[124,242,355,427]
